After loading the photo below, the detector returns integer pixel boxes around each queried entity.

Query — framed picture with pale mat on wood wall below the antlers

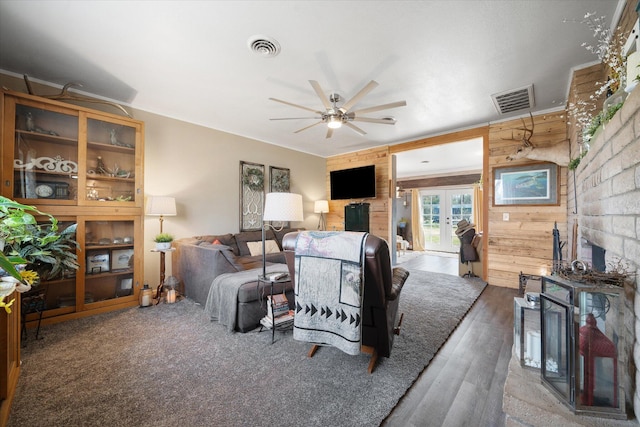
[493,163,560,206]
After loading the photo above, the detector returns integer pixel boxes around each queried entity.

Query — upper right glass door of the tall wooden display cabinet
[84,117,141,205]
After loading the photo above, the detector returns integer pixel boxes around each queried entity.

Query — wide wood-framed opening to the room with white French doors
[393,132,486,274]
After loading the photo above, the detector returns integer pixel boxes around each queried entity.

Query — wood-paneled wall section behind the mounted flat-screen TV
[327,146,391,240]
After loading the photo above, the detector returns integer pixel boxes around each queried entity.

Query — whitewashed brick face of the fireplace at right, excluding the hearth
[567,88,640,416]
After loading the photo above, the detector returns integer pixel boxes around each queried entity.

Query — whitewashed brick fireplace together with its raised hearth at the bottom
[503,86,640,426]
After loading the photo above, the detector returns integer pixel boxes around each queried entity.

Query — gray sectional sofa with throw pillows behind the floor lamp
[172,229,297,332]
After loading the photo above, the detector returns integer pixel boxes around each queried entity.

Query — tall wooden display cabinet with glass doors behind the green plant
[0,90,144,326]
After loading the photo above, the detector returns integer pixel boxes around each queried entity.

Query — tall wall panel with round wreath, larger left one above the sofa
[240,161,264,231]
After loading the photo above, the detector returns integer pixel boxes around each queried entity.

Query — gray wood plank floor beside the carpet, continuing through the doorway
[382,255,517,427]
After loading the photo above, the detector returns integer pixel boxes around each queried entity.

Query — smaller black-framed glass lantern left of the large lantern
[513,298,542,369]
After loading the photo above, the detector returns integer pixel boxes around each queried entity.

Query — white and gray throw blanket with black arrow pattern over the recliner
[293,231,367,355]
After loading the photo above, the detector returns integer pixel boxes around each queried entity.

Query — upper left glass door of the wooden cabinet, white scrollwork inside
[11,103,78,204]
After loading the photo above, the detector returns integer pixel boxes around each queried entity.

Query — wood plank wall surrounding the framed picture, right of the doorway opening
[487,111,569,288]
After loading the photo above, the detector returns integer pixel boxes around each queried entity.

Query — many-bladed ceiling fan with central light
[269,80,407,138]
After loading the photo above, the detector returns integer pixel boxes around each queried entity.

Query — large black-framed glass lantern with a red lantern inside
[541,276,626,419]
